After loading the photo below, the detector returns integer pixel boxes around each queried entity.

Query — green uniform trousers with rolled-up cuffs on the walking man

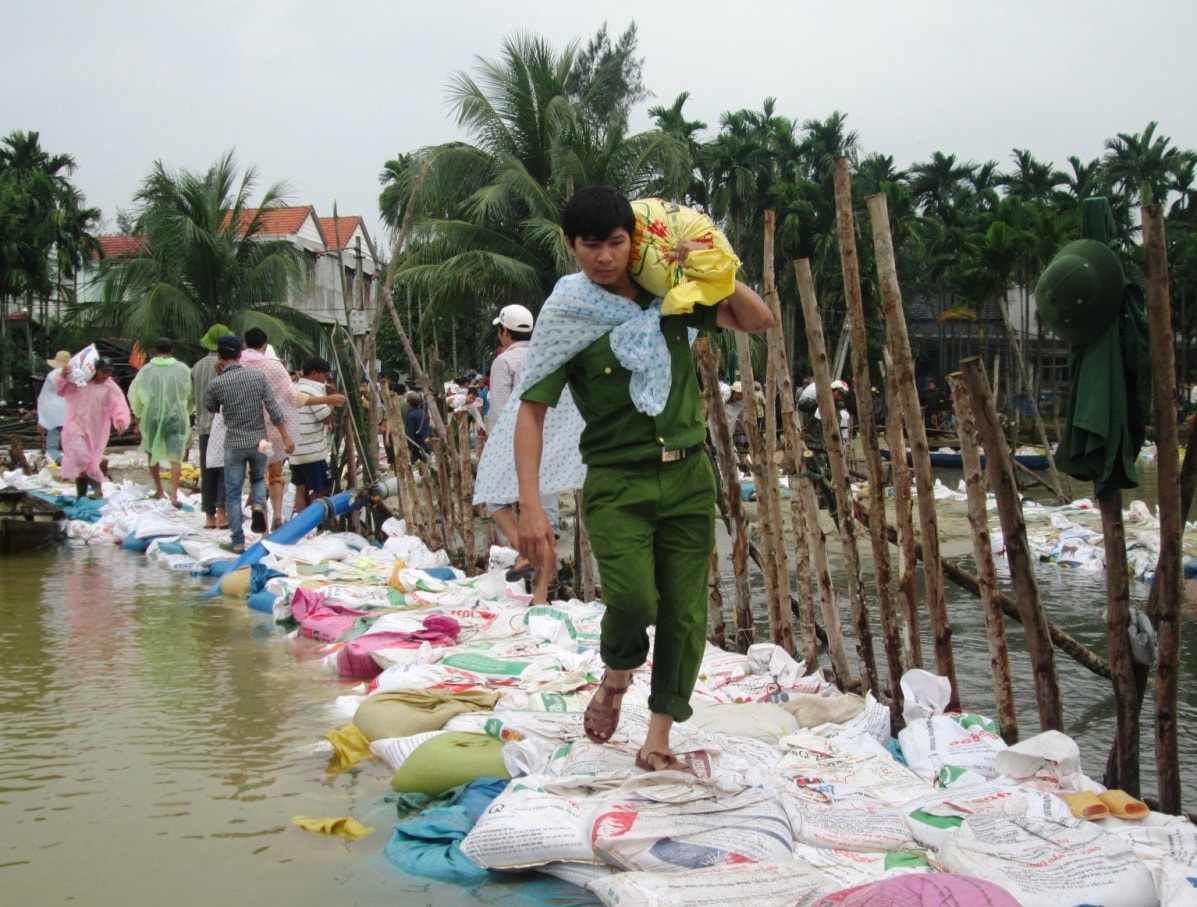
[583,450,716,722]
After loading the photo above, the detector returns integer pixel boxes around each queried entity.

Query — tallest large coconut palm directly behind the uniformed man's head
[383,24,693,361]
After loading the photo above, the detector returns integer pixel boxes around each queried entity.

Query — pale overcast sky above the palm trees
[0,0,1197,244]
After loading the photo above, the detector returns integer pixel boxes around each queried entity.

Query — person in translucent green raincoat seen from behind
[128,337,192,507]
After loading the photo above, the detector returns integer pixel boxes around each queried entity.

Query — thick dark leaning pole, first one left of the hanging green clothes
[960,357,1064,731]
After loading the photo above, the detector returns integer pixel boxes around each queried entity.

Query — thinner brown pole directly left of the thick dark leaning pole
[948,372,1019,745]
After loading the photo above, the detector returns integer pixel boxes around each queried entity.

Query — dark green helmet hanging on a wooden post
[1035,239,1124,346]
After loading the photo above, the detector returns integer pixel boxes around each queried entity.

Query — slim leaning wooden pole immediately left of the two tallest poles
[794,258,882,700]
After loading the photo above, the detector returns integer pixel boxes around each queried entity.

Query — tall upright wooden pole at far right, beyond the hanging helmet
[1142,205,1193,815]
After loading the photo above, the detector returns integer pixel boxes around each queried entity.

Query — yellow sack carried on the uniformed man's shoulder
[627,199,740,315]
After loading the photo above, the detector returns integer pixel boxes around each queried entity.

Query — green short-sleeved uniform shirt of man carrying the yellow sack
[521,291,717,465]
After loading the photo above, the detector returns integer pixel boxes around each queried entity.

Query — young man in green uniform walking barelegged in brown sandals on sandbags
[515,188,773,771]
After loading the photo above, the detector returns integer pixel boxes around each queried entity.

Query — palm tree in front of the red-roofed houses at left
[86,151,315,351]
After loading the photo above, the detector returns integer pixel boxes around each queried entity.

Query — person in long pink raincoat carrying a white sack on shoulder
[54,357,133,498]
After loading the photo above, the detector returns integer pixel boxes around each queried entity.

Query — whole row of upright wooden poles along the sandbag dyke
[344,159,1197,814]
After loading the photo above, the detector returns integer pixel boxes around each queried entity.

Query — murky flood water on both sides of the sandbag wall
[0,464,1197,907]
